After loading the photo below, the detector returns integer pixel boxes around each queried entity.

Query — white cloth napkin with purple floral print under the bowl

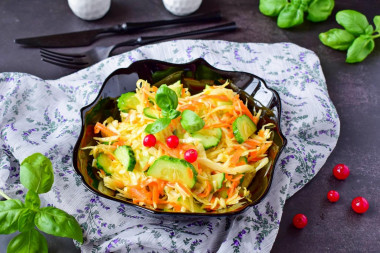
[0,40,340,252]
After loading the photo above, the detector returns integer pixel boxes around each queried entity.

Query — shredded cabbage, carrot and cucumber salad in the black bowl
[84,79,273,212]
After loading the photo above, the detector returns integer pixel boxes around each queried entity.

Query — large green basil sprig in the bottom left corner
[0,153,83,253]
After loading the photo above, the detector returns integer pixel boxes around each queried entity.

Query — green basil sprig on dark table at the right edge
[319,10,380,63]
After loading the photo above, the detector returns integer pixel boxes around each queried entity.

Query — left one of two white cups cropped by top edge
[68,0,111,20]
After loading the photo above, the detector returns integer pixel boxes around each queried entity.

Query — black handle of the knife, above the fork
[106,11,222,33]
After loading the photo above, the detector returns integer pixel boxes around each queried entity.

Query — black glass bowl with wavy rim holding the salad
[73,58,286,216]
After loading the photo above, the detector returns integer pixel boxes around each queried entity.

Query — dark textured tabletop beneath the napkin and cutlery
[0,0,380,253]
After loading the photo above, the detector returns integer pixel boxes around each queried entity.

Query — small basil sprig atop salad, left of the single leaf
[145,84,181,134]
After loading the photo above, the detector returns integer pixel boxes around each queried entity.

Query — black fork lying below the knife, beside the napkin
[40,22,237,69]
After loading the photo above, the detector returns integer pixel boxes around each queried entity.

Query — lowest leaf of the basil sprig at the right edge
[346,35,375,63]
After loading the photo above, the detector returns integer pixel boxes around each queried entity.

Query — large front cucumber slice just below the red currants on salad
[147,156,197,188]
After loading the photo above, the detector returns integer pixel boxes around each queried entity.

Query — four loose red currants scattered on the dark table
[293,164,369,228]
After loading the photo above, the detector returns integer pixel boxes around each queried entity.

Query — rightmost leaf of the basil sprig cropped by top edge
[307,0,335,22]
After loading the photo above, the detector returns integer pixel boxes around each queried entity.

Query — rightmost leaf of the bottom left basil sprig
[34,206,83,243]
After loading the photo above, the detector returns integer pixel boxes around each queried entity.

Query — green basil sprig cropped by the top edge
[259,0,335,28]
